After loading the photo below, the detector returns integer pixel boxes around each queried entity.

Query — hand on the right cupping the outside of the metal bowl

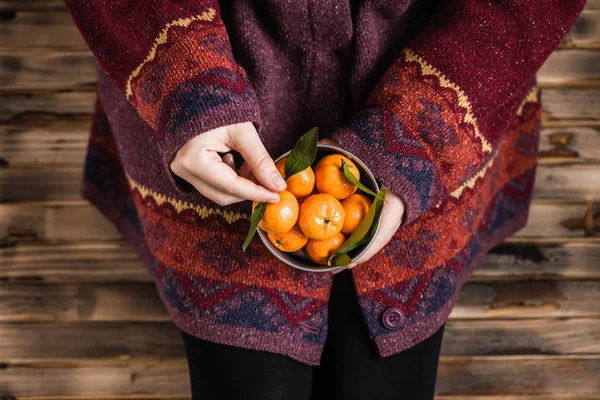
[333,191,404,274]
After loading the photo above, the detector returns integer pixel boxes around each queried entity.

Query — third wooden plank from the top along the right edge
[542,88,600,120]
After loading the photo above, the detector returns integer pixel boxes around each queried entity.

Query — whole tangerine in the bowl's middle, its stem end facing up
[298,193,346,240]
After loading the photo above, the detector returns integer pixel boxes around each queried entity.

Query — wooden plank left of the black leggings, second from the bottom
[0,322,183,365]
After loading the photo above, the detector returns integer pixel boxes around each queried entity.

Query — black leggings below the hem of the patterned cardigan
[182,270,444,400]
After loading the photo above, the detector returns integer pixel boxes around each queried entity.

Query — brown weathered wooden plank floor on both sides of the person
[0,0,600,400]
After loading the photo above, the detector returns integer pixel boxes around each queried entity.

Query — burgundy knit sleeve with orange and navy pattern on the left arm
[66,0,260,191]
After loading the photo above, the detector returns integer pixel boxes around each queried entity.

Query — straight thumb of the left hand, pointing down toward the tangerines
[227,122,287,192]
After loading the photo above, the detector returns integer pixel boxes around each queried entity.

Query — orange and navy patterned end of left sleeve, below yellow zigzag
[120,16,260,193]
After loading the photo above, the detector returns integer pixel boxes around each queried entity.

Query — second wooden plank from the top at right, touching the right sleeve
[537,50,600,86]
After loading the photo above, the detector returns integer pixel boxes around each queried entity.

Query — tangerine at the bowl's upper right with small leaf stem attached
[315,154,360,200]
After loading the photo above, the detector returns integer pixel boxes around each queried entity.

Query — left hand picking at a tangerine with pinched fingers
[170,122,286,206]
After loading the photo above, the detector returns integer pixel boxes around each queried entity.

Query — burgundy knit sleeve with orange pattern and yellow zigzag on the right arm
[332,0,585,224]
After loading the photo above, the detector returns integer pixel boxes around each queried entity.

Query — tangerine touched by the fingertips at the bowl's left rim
[252,190,300,233]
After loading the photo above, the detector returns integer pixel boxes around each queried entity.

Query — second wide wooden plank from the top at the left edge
[0,51,96,91]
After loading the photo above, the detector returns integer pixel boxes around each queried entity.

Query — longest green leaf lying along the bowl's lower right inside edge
[328,189,387,265]
